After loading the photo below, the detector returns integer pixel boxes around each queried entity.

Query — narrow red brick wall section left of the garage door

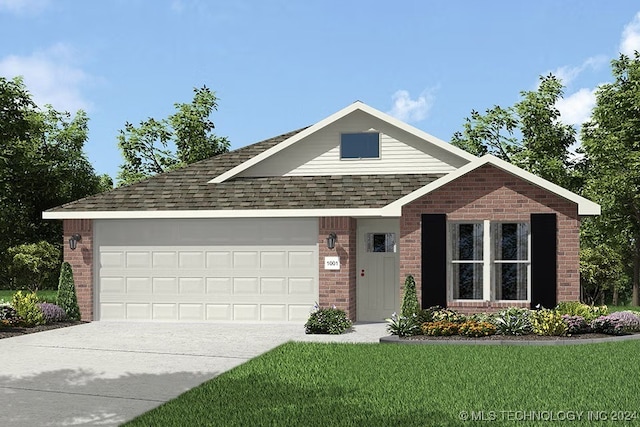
[64,219,93,321]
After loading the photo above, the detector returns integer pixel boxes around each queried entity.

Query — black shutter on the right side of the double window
[531,214,558,308]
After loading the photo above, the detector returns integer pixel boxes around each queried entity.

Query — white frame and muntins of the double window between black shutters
[447,219,531,303]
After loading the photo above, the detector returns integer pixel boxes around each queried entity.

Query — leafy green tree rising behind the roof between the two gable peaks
[451,74,579,189]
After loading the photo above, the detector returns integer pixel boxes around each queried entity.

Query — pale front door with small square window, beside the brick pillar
[356,219,400,322]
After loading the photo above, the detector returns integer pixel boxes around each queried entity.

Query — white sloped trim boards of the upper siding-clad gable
[211,101,476,183]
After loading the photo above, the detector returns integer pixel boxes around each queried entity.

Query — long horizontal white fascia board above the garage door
[42,208,390,219]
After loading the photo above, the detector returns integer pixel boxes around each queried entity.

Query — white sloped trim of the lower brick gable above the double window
[383,154,600,216]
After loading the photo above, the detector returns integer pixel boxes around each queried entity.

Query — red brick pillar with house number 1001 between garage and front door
[318,217,356,320]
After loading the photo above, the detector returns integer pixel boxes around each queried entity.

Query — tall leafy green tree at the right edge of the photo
[582,52,640,305]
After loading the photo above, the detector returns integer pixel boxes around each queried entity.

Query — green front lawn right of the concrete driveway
[126,341,640,427]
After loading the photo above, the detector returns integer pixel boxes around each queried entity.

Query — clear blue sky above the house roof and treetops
[0,0,640,181]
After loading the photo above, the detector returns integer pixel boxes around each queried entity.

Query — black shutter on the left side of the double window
[422,214,447,308]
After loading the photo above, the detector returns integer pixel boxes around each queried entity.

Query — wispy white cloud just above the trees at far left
[0,44,92,113]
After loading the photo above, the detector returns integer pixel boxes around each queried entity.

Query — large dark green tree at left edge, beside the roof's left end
[0,77,106,286]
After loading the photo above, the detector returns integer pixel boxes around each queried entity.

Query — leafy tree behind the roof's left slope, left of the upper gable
[118,86,229,185]
